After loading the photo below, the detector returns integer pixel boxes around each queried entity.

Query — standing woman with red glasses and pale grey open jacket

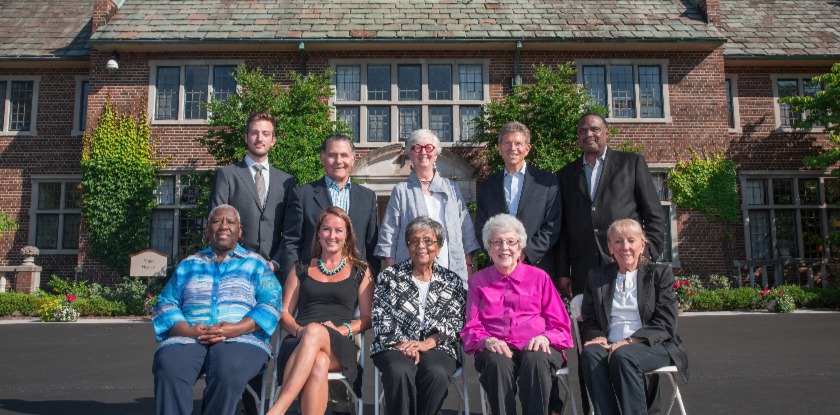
[374,129,480,286]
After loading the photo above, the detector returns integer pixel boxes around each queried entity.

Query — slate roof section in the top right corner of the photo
[720,0,840,59]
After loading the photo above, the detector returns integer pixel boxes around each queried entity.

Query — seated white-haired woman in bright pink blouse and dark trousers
[461,213,573,415]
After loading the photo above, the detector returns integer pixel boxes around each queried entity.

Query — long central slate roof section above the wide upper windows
[92,0,722,44]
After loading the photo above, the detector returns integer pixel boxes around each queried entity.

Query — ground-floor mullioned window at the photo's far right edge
[741,173,840,259]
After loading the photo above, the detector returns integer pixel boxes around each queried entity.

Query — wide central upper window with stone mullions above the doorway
[331,60,490,145]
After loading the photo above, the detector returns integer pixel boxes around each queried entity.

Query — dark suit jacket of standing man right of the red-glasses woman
[475,164,561,277]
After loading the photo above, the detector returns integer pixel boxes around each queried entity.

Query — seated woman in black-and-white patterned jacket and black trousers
[370,216,466,415]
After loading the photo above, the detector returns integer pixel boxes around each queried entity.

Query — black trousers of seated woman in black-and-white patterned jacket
[371,349,457,415]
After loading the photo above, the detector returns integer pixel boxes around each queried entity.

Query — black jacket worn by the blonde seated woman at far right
[580,261,689,382]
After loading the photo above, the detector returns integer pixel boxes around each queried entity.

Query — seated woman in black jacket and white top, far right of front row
[580,219,688,415]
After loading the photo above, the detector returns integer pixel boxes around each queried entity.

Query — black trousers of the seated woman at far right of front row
[580,343,671,415]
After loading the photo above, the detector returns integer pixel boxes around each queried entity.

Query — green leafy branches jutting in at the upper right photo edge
[779,63,840,174]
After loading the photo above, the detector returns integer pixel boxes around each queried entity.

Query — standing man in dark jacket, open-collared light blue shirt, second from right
[475,121,560,277]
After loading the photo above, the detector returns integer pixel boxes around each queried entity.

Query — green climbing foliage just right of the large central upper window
[475,62,607,172]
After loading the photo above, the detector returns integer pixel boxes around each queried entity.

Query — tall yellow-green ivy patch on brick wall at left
[82,102,165,275]
